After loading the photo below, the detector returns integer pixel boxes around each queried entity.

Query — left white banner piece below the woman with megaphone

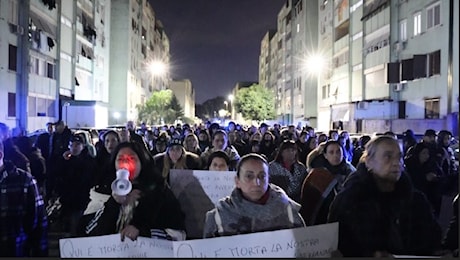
[59,234,173,258]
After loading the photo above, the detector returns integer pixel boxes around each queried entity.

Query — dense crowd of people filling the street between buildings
[0,120,458,256]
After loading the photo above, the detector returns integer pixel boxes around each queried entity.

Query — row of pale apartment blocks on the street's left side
[0,0,169,132]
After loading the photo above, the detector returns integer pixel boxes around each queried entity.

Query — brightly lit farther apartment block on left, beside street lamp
[109,0,169,124]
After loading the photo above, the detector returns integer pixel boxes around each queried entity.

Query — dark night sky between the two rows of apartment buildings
[149,0,285,104]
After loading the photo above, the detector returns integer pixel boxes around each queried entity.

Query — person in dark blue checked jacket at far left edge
[0,141,48,257]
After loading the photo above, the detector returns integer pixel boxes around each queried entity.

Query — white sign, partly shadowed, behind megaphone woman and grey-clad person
[169,170,236,238]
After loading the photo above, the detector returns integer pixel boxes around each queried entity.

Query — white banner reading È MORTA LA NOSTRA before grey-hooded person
[173,222,339,258]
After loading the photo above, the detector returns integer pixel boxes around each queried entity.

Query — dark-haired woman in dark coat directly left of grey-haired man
[300,140,356,225]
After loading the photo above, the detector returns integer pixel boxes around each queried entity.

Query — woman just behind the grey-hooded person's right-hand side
[270,140,307,202]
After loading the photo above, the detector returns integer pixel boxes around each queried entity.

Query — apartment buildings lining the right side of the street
[264,0,459,135]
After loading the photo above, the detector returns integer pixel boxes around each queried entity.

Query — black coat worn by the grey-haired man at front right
[328,167,441,257]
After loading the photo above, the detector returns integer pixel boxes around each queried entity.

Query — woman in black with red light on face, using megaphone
[85,142,185,241]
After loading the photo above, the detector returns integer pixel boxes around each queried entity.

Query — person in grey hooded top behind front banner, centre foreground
[203,153,305,238]
